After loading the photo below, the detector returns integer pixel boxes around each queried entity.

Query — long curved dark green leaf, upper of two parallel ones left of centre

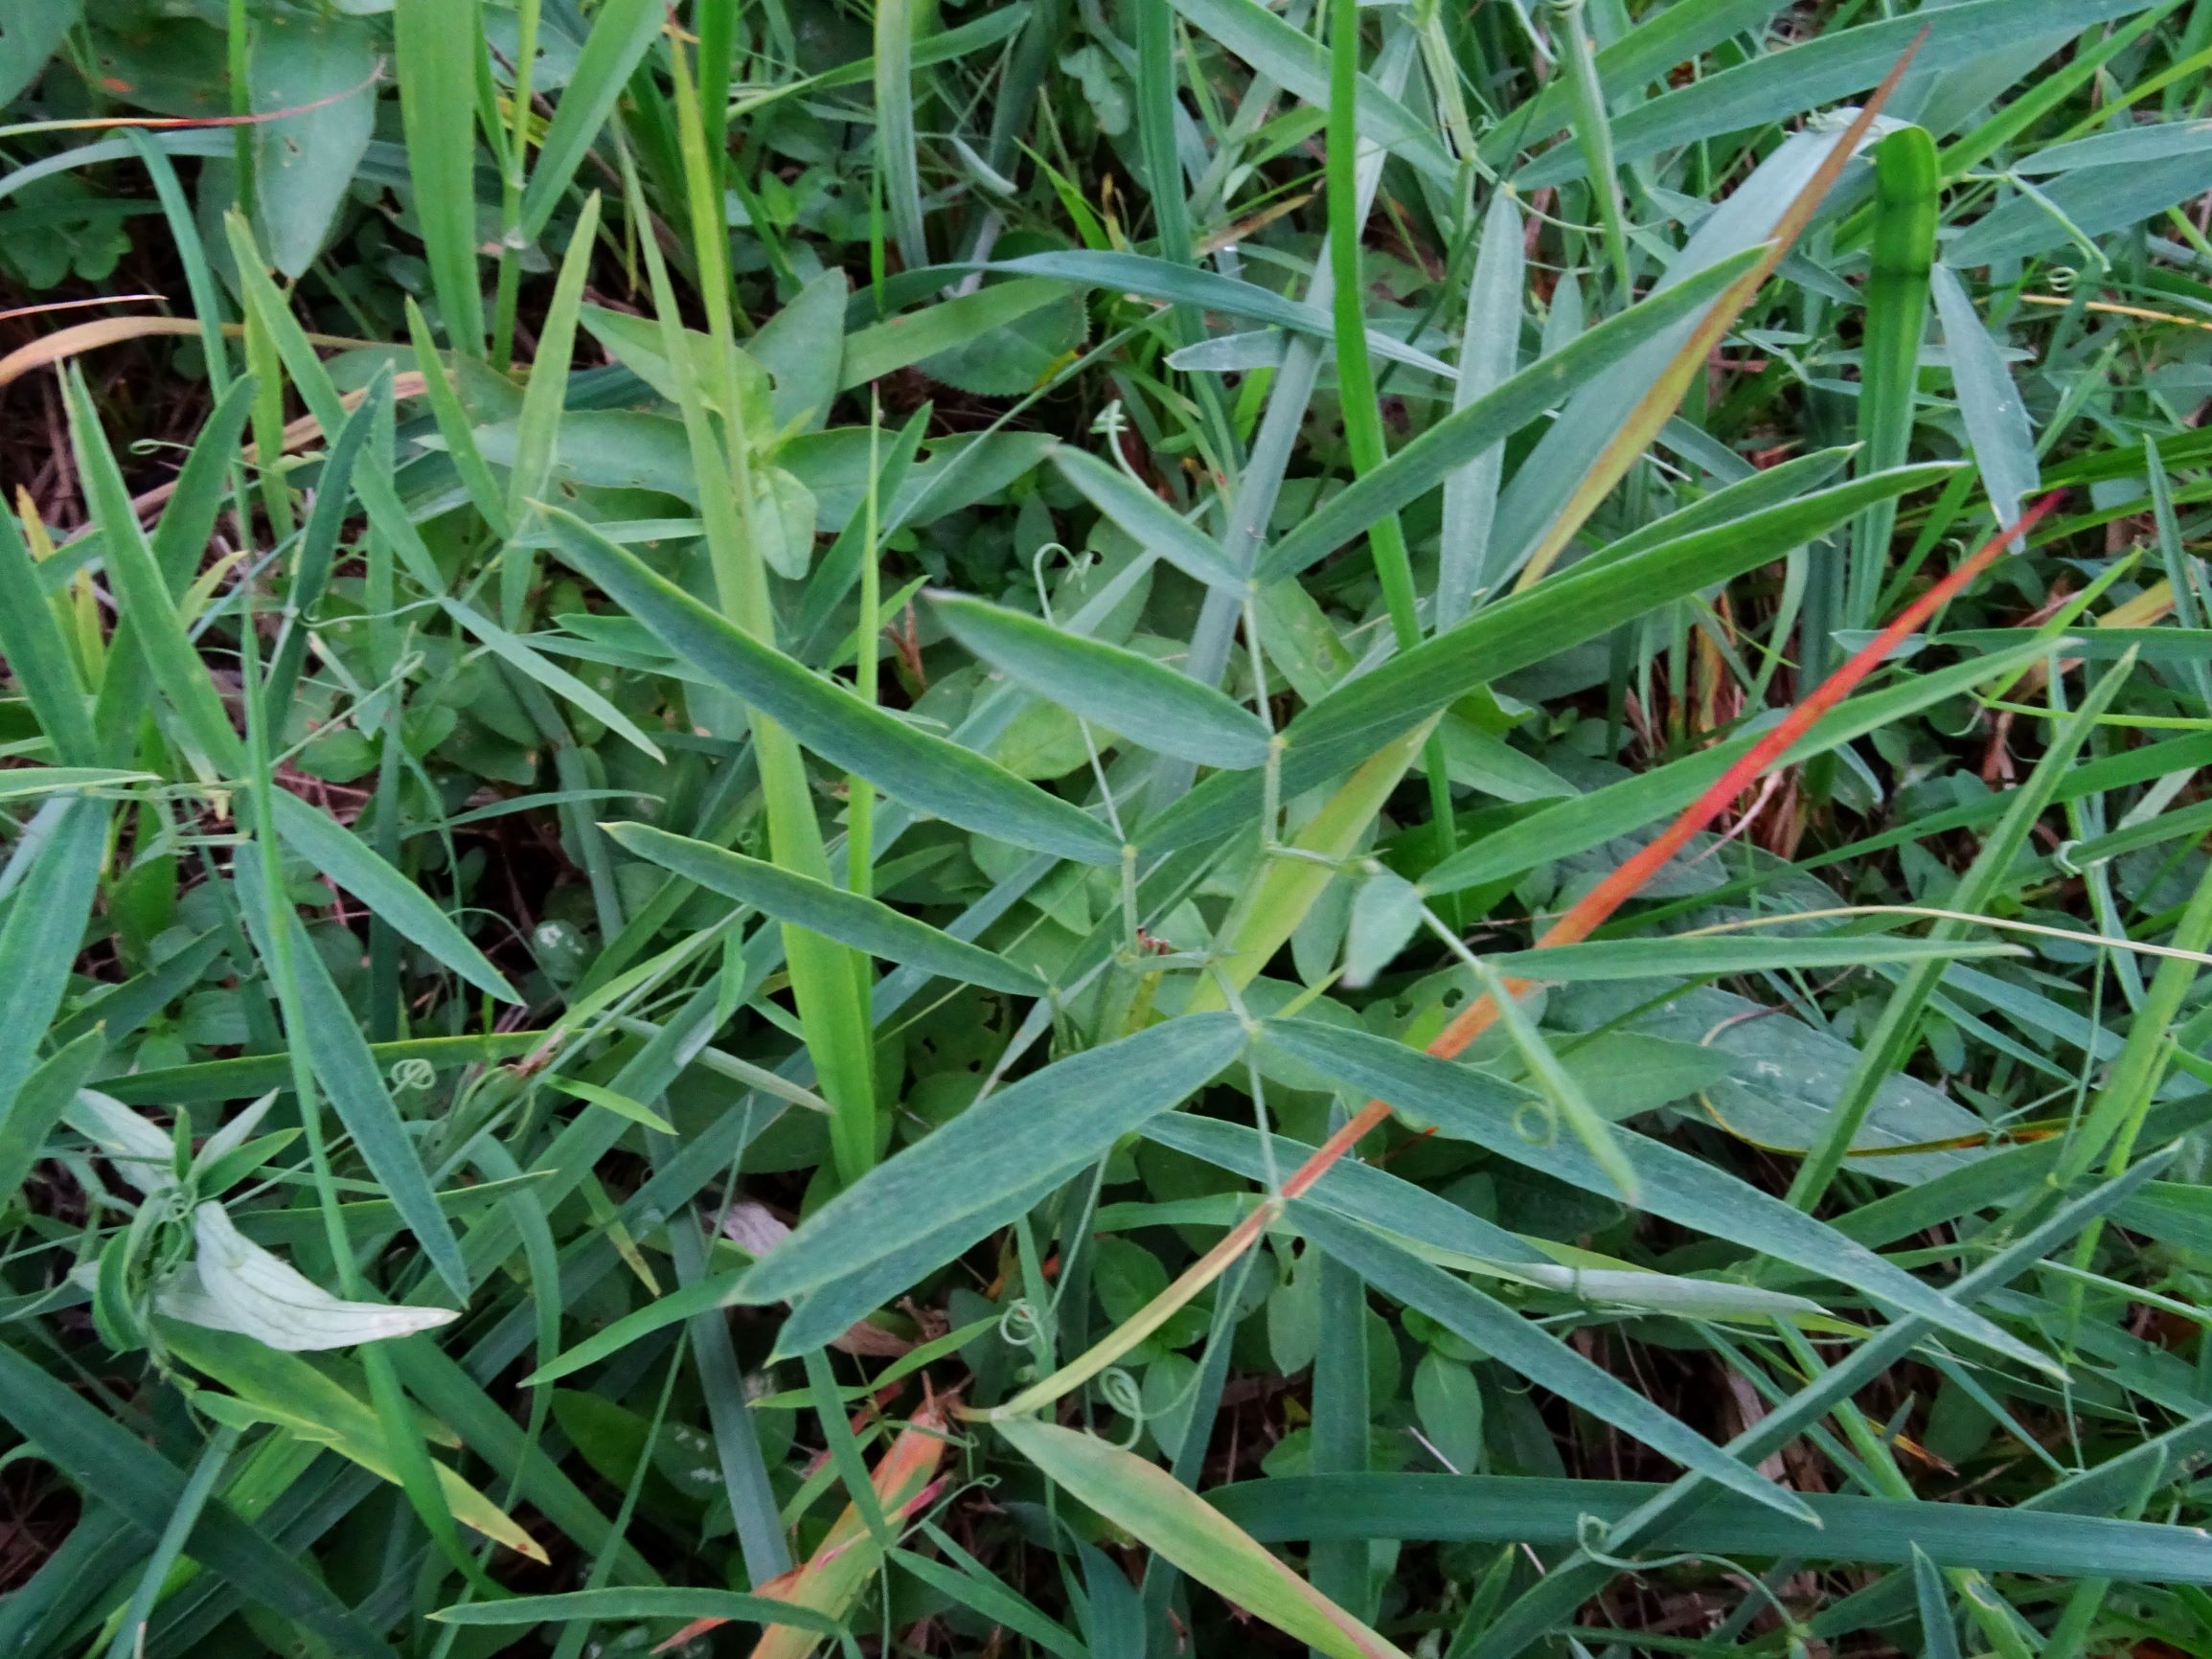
[539,507,1122,865]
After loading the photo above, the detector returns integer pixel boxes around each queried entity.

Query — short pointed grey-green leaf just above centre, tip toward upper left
[929,591,1272,770]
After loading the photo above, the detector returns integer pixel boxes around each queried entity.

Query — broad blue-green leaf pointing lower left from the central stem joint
[739,1013,1245,1303]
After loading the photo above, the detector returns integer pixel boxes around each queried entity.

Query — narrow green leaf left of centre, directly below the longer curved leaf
[602,823,1044,995]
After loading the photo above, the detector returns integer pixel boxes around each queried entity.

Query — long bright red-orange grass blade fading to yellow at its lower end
[962,491,2066,1424]
